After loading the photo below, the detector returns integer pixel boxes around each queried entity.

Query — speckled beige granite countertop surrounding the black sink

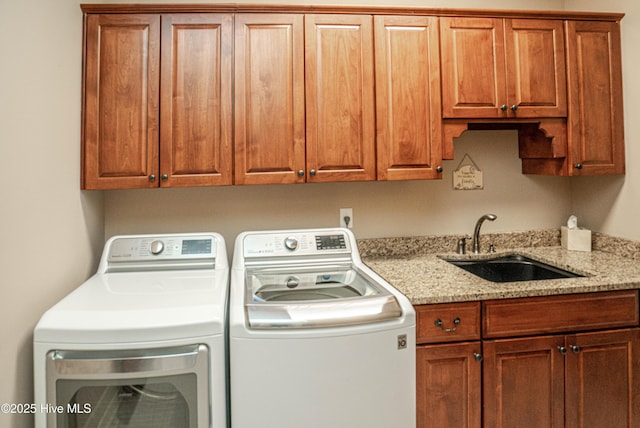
[359,232,640,305]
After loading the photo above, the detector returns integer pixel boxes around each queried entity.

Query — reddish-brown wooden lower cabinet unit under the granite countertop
[416,290,640,428]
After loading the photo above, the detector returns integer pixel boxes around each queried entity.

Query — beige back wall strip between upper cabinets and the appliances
[105,131,571,256]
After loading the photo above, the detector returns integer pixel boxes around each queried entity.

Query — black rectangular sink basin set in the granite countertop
[447,254,584,282]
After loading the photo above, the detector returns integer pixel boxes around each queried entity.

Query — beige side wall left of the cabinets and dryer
[0,0,104,427]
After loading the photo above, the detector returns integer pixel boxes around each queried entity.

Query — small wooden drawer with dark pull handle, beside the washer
[415,302,480,344]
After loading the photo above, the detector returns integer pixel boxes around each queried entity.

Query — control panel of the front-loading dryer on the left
[108,235,216,263]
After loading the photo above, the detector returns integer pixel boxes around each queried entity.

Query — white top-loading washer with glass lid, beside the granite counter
[229,229,416,428]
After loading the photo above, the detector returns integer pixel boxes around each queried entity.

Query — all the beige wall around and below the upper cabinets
[0,0,640,427]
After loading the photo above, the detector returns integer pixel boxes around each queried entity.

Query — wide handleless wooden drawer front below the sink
[482,290,639,338]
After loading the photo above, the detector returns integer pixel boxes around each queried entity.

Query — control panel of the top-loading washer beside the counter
[243,230,351,257]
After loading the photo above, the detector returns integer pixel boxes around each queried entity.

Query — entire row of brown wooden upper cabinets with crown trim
[81,4,625,189]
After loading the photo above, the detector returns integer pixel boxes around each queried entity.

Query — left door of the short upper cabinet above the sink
[440,17,507,118]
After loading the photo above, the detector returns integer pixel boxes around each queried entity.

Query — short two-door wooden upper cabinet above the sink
[440,17,567,118]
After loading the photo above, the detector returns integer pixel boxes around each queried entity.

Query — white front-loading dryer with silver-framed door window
[34,233,229,428]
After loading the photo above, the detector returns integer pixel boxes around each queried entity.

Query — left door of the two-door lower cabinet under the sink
[483,336,565,428]
